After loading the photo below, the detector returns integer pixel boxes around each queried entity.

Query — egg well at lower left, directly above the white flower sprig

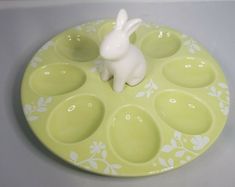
[48,96,104,143]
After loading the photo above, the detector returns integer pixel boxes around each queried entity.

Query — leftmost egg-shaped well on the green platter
[30,63,86,96]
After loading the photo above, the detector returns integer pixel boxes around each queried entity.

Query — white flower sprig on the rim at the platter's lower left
[69,141,121,175]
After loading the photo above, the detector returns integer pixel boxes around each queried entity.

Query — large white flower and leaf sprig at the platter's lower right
[159,131,209,170]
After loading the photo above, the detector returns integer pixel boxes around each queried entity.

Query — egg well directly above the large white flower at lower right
[155,91,212,134]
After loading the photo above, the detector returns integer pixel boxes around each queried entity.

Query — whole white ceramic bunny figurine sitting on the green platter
[100,9,146,92]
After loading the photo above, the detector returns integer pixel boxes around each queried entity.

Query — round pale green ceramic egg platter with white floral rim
[21,20,229,176]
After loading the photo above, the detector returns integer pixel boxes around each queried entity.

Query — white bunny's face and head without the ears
[100,30,129,60]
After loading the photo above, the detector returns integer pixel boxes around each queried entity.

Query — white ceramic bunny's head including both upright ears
[100,9,142,60]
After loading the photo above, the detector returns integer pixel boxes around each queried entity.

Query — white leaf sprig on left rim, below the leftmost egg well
[23,97,52,122]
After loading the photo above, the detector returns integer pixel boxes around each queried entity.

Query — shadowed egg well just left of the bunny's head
[56,31,99,62]
